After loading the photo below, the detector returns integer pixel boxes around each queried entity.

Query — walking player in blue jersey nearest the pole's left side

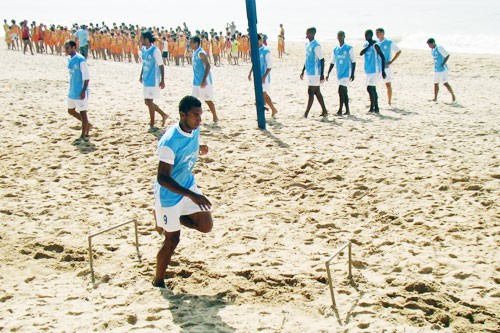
[190,36,219,123]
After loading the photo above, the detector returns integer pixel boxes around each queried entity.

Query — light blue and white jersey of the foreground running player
[155,124,200,207]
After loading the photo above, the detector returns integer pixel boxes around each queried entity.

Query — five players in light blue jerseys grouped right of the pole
[300,27,456,118]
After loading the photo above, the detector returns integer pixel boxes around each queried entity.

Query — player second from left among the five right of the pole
[326,31,356,116]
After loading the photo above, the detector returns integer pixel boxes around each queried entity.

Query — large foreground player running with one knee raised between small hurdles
[153,96,213,288]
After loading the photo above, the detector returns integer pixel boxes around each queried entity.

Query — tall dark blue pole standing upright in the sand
[245,0,266,129]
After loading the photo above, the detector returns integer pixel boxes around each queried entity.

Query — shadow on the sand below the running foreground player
[162,289,236,333]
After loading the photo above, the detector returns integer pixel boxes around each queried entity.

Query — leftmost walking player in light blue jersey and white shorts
[64,40,92,141]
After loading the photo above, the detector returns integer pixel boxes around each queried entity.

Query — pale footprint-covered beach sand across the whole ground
[0,43,500,332]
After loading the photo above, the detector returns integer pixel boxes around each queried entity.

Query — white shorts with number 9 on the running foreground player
[155,185,206,232]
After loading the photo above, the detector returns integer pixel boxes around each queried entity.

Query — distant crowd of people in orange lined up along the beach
[3,19,284,66]
